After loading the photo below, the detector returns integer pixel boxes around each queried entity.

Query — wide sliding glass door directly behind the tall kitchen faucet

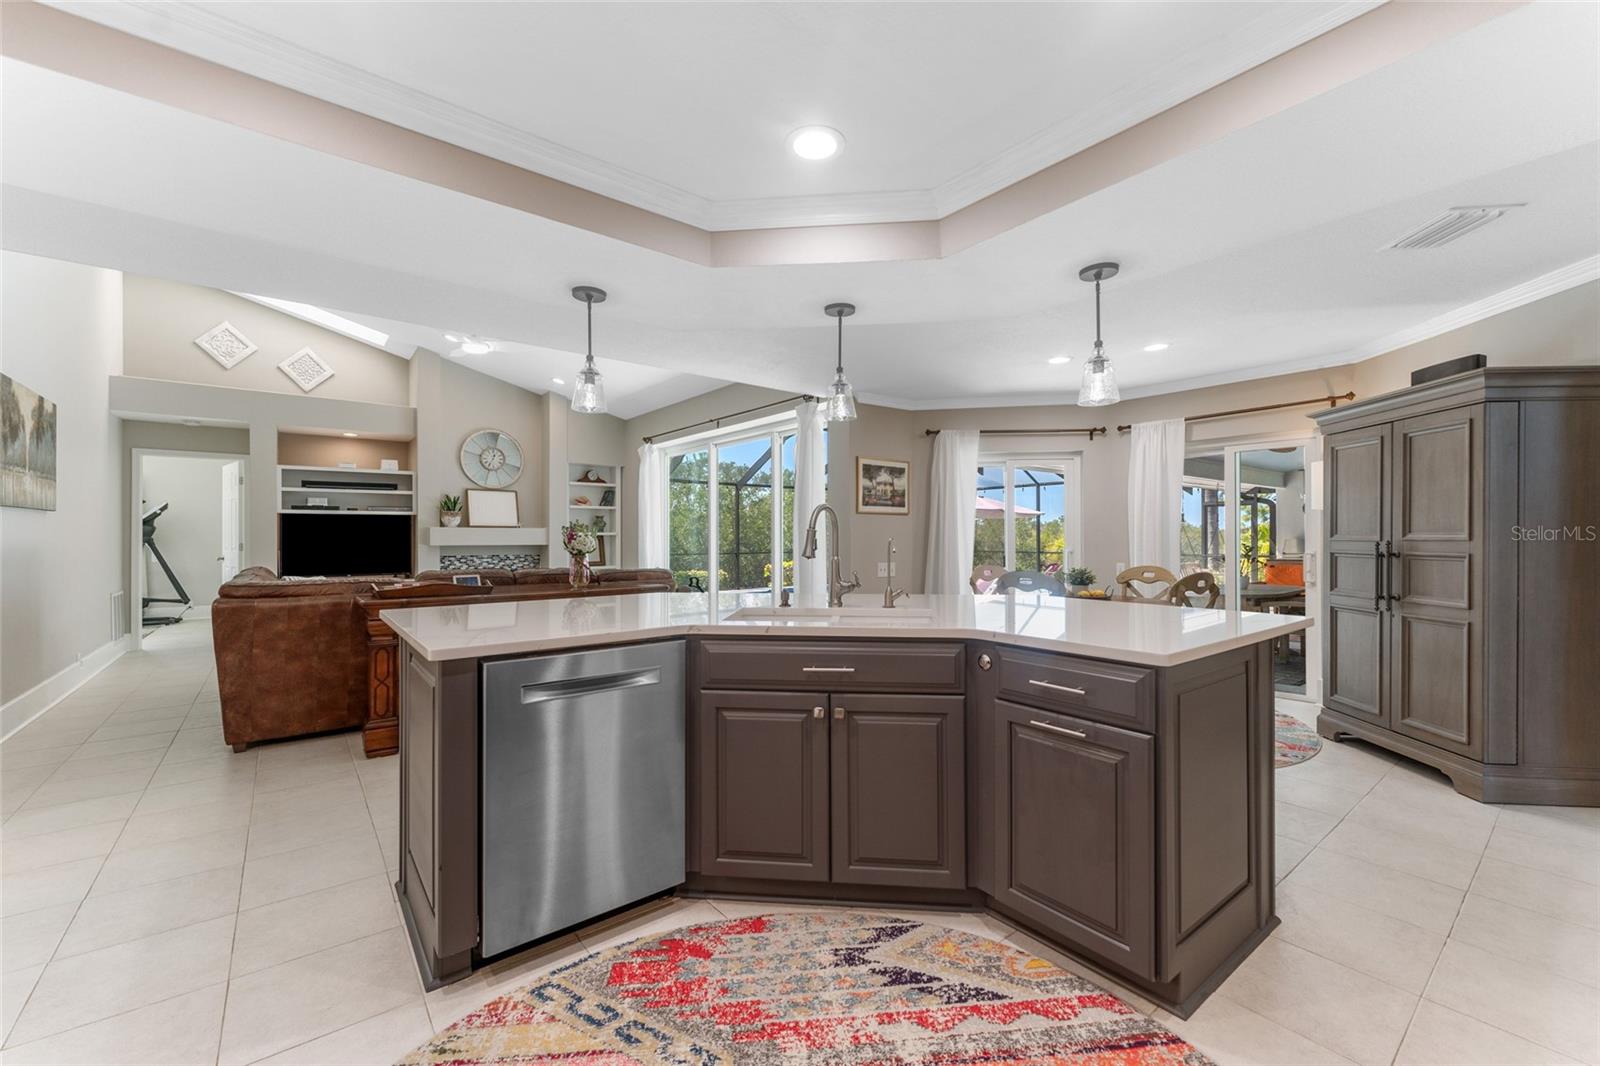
[667,421,795,595]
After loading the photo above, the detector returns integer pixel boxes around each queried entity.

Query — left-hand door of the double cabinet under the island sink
[699,691,829,880]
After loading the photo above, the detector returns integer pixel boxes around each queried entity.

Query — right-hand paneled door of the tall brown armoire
[1387,407,1483,759]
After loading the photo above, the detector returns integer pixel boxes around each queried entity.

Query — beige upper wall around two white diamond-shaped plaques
[123,274,406,403]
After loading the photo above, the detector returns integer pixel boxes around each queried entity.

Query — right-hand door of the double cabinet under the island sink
[832,695,966,888]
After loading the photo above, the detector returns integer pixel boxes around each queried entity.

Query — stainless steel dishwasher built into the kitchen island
[480,640,686,956]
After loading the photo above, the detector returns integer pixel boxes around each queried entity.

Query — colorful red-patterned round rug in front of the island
[403,911,1210,1066]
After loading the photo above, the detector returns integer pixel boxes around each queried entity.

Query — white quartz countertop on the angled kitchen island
[381,592,1310,666]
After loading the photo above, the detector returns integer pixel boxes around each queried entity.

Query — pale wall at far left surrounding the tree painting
[0,251,126,704]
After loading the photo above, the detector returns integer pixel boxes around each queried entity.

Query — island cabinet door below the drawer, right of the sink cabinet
[994,701,1155,976]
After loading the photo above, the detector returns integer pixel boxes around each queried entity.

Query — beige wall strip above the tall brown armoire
[1355,282,1600,397]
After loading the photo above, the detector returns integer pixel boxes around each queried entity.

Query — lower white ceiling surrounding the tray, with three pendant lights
[0,3,1600,407]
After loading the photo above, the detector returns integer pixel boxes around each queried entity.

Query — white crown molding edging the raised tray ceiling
[43,0,1382,232]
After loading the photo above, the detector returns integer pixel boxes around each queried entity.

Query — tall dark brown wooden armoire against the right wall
[1317,367,1600,805]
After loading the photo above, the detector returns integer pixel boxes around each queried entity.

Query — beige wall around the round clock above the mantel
[410,349,547,570]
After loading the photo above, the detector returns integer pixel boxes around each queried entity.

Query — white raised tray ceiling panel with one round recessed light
[56,0,1376,229]
